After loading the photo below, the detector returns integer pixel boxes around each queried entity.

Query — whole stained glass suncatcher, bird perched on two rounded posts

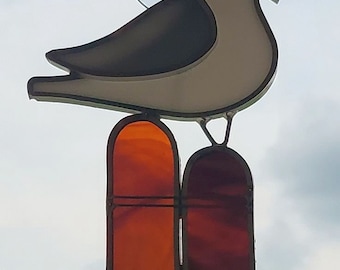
[27,0,278,270]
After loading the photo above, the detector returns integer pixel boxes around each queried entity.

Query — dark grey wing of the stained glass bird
[46,0,217,77]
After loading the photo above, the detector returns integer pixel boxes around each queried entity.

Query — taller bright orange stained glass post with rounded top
[107,117,179,270]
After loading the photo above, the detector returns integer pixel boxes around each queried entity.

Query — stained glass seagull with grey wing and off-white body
[27,0,278,121]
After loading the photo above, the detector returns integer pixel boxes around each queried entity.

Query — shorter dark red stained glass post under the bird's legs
[183,147,254,270]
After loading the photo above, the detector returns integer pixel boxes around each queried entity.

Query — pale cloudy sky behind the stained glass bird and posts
[0,0,340,270]
